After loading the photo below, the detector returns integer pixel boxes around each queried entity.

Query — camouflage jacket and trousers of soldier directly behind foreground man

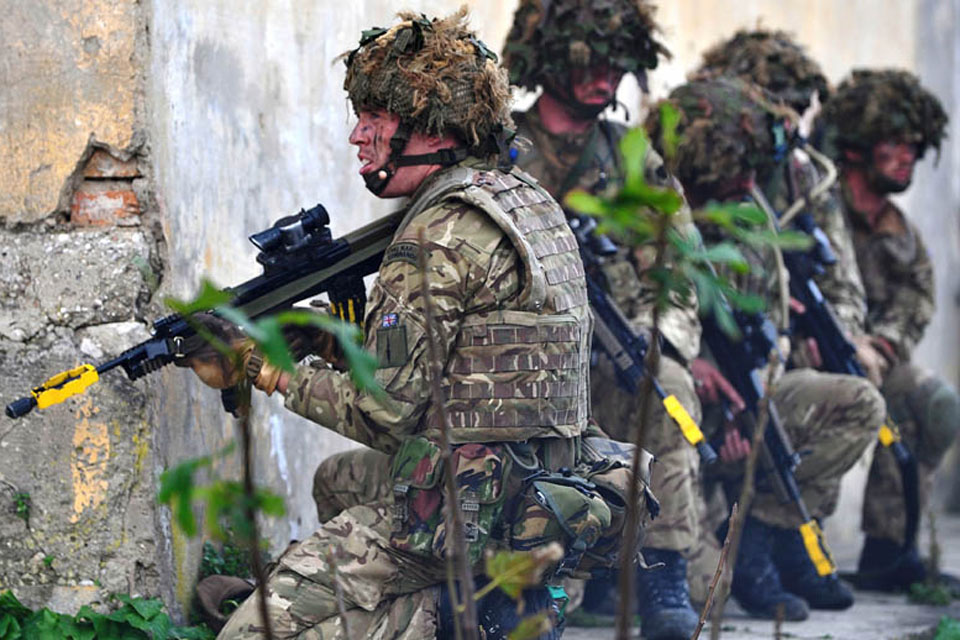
[513,109,700,551]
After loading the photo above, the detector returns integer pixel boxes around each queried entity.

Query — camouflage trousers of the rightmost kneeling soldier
[862,364,960,544]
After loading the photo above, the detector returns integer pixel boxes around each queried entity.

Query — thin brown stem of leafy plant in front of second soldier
[616,214,670,640]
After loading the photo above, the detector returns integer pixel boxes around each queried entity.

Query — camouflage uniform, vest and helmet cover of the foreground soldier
[219,12,591,638]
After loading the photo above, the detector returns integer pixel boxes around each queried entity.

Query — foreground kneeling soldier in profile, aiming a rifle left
[180,9,609,638]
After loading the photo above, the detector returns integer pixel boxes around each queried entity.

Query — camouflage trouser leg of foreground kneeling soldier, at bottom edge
[217,502,445,640]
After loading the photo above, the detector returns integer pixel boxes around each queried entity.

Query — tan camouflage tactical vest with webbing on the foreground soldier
[398,166,592,443]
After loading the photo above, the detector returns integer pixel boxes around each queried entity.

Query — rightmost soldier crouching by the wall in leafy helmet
[823,70,960,590]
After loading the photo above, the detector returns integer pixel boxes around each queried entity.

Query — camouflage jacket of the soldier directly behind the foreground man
[513,107,700,362]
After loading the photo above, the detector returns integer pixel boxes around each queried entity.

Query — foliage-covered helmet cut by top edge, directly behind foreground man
[503,0,670,91]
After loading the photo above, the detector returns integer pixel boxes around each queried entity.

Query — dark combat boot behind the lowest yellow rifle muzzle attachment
[771,527,853,611]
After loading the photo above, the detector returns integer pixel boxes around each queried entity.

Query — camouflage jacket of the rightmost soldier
[843,189,935,361]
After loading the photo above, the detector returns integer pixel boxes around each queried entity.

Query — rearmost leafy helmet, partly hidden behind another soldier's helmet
[693,30,830,114]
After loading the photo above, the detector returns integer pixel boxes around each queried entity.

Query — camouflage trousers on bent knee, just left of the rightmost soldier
[750,369,886,528]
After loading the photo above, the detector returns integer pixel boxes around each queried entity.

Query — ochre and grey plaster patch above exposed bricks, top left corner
[0,0,138,225]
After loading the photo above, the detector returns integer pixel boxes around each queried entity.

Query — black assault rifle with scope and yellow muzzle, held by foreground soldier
[6,204,405,418]
